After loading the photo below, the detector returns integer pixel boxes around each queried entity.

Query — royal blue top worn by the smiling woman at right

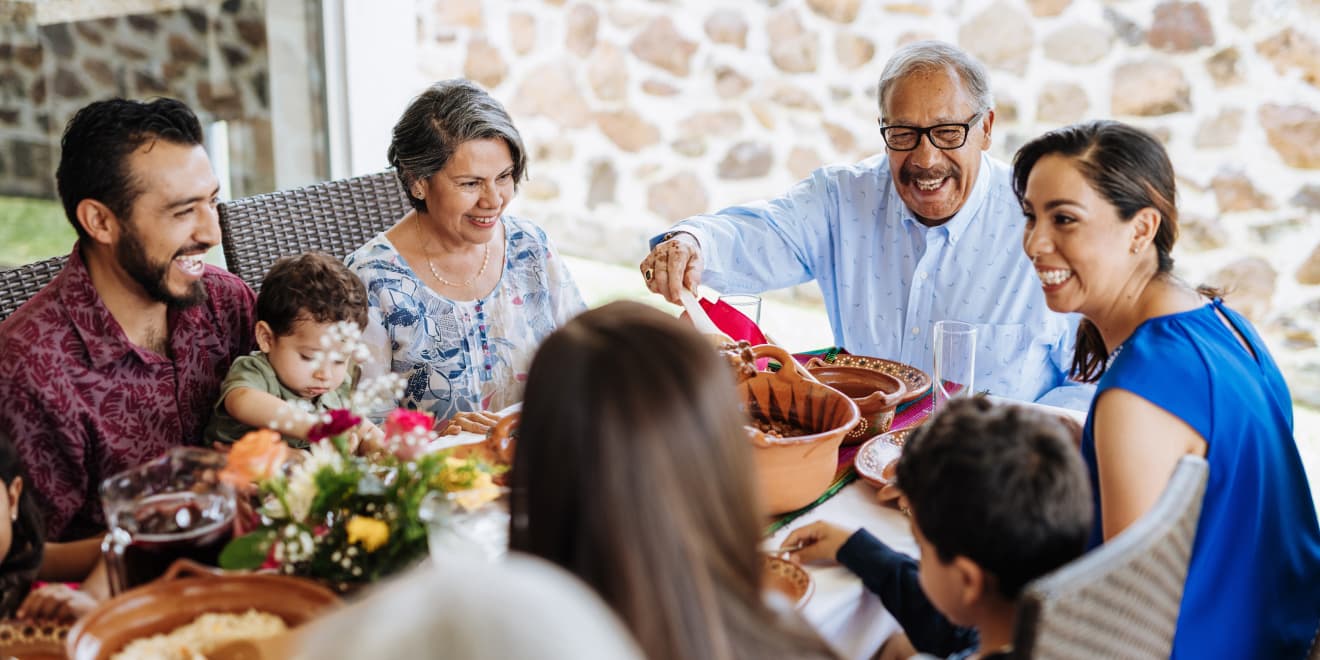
[1081,300,1320,659]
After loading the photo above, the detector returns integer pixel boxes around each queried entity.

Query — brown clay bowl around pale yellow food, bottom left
[65,560,339,660]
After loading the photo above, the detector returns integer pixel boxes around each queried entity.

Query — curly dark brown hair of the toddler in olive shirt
[256,252,367,337]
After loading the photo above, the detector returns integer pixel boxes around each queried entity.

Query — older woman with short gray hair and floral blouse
[347,79,585,432]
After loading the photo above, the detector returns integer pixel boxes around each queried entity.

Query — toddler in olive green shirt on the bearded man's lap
[206,252,376,449]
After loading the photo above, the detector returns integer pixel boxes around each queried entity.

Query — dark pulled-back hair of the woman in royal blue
[1012,120,1214,383]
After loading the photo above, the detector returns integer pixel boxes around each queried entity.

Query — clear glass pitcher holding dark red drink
[100,447,235,594]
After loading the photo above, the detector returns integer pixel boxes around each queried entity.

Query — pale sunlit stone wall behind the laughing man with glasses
[416,0,1320,405]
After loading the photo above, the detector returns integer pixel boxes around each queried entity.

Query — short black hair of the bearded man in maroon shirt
[55,99,203,239]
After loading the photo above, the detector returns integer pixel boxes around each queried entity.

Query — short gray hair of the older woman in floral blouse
[387,78,527,211]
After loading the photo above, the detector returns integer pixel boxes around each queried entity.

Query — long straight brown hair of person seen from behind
[510,302,830,660]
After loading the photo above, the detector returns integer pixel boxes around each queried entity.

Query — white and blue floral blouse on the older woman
[345,215,586,420]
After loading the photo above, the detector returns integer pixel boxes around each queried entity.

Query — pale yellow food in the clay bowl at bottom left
[111,610,289,660]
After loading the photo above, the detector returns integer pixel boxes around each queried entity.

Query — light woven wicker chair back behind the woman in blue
[1014,455,1209,659]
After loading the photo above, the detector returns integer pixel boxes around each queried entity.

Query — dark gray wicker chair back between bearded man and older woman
[220,170,411,289]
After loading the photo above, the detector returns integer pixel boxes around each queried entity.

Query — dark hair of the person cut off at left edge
[0,432,46,618]
